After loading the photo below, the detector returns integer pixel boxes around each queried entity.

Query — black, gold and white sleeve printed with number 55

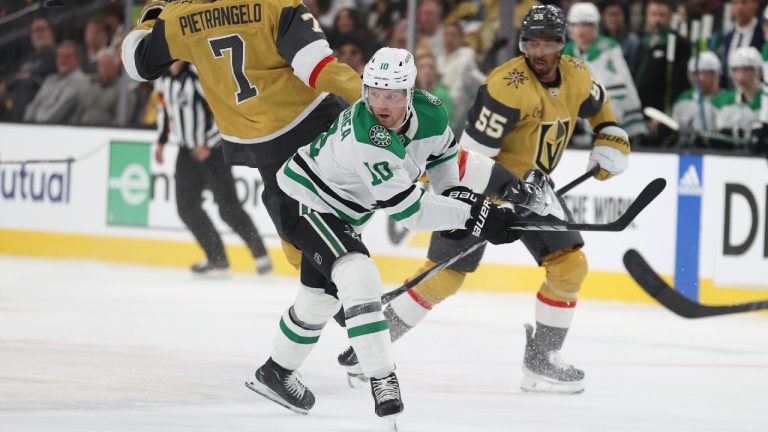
[459,84,520,157]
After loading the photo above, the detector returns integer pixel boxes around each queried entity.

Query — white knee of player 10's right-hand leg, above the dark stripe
[331,252,382,308]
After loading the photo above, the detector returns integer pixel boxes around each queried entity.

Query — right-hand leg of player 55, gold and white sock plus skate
[521,231,587,393]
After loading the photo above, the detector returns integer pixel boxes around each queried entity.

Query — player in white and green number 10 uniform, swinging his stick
[246,48,536,417]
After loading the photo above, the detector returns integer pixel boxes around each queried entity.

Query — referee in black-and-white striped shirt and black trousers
[155,61,272,275]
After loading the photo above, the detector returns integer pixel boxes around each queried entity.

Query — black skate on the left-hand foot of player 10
[245,358,315,414]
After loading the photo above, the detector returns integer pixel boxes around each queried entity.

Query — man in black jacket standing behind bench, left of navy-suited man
[634,0,691,113]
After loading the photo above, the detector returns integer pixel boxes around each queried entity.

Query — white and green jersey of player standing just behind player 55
[563,35,648,137]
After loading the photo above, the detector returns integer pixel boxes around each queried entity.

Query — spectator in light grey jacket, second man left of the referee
[24,41,88,124]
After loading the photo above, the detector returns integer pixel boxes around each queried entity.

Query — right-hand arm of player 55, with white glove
[579,76,630,180]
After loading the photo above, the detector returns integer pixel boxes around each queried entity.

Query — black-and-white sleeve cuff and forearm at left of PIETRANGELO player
[121,0,174,81]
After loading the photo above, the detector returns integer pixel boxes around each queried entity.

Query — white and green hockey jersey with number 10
[277,90,470,231]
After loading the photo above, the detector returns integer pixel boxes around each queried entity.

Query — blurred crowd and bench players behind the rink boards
[0,0,768,152]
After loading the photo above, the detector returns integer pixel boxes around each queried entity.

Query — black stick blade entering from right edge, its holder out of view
[624,249,768,318]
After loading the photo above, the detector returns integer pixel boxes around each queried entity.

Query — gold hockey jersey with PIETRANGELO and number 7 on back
[123,0,360,145]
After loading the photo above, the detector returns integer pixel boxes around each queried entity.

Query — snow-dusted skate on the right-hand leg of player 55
[520,323,584,394]
